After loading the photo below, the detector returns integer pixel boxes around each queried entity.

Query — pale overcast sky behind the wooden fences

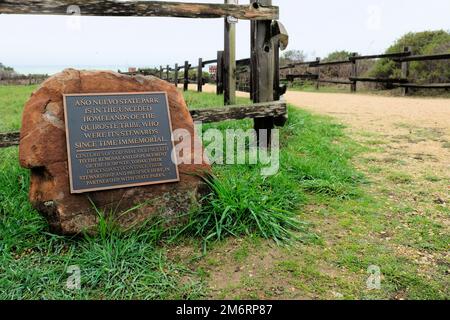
[0,0,450,73]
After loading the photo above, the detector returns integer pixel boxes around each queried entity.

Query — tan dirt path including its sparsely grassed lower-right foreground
[185,85,450,299]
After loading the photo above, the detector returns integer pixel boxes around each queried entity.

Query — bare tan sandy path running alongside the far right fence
[197,85,450,169]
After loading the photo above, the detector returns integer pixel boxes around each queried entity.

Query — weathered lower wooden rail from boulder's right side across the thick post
[191,101,287,123]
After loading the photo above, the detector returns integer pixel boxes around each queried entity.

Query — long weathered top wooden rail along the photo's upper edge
[0,0,279,20]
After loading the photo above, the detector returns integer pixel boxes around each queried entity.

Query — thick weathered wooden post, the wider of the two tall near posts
[251,0,275,145]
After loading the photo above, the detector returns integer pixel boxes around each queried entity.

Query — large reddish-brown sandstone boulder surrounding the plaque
[19,69,210,235]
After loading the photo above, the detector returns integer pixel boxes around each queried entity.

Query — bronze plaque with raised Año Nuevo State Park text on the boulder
[64,92,179,193]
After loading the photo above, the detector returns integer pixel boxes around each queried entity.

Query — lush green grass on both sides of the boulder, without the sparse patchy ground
[0,87,362,299]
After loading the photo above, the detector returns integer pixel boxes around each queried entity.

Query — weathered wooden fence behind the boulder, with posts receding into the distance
[0,0,287,147]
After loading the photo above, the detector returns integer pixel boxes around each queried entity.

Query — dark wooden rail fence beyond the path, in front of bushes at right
[280,47,450,95]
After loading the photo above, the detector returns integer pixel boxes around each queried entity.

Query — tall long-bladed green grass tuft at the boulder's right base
[178,169,312,248]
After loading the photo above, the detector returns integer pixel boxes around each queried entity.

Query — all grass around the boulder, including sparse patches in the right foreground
[0,87,449,299]
